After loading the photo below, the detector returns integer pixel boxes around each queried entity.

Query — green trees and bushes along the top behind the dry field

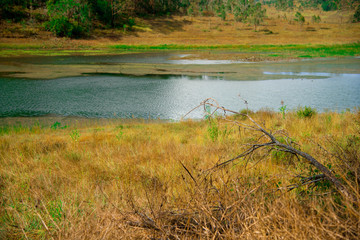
[0,0,360,37]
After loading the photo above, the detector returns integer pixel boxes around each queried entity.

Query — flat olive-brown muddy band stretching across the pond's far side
[0,53,360,80]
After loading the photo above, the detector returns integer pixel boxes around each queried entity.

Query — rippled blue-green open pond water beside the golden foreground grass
[0,55,360,120]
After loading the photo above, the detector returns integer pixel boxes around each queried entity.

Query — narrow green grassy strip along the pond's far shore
[0,43,360,61]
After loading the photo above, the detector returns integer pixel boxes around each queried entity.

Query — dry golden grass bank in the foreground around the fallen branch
[0,111,360,239]
